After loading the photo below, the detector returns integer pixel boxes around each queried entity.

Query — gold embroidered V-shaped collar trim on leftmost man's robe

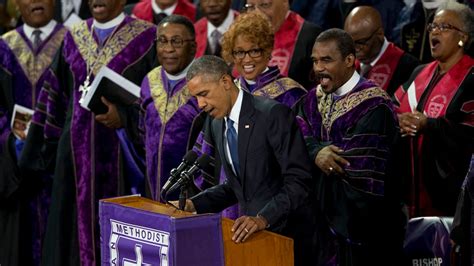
[3,28,67,88]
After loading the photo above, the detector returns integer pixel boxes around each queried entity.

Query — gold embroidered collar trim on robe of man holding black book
[71,20,154,76]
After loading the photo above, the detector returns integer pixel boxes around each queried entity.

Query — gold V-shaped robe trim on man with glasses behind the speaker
[147,66,192,125]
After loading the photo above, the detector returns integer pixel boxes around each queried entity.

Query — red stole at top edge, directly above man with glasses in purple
[132,0,196,23]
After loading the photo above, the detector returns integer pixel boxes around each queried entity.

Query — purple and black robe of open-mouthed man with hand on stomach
[295,78,404,263]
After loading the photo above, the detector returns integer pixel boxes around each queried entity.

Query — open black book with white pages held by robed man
[81,66,140,114]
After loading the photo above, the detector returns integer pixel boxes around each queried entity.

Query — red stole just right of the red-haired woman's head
[268,11,304,76]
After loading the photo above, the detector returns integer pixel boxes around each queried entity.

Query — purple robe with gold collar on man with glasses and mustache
[140,67,200,200]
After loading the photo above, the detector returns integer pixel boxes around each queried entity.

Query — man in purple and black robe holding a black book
[25,0,157,265]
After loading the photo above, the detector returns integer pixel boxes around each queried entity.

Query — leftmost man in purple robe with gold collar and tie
[0,0,66,265]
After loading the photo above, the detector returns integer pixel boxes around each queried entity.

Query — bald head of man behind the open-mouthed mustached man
[344,6,385,63]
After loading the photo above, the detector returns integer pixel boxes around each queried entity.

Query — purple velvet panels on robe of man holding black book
[58,16,156,265]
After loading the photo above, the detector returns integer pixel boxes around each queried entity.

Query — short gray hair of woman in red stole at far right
[436,2,474,52]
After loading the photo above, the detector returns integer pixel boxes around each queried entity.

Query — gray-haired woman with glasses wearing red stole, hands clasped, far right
[394,2,474,220]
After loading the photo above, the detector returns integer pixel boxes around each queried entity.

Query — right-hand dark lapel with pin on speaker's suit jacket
[238,92,255,188]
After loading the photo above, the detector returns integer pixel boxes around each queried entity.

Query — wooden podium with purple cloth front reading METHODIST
[99,196,294,266]
